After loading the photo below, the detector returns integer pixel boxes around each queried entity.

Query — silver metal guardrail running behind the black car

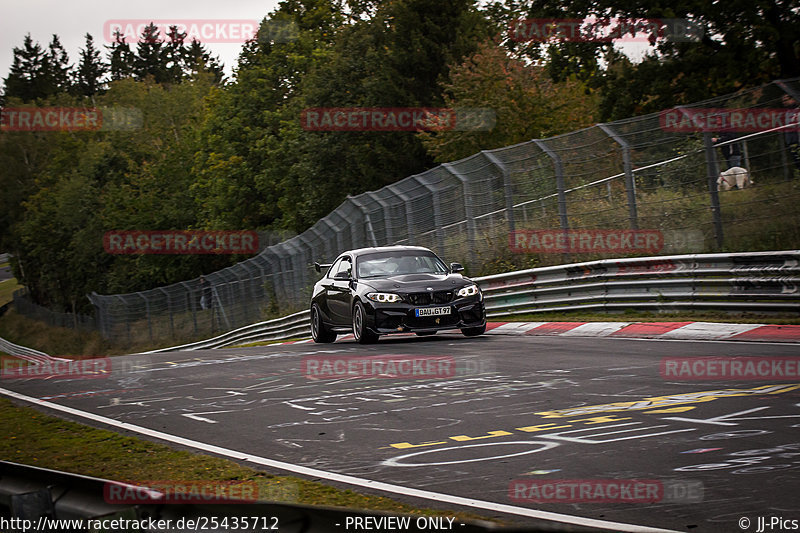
[145,250,800,353]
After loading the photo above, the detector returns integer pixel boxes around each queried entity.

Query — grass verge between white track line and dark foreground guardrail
[0,398,486,520]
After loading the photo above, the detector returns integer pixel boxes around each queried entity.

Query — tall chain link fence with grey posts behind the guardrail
[73,78,800,344]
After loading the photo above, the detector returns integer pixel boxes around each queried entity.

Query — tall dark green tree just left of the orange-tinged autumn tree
[272,0,488,232]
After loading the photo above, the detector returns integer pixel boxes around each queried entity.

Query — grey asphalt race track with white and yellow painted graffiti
[0,334,800,532]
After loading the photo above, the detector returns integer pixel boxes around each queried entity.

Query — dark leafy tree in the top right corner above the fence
[489,0,800,120]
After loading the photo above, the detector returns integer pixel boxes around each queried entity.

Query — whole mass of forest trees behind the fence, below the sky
[0,0,800,320]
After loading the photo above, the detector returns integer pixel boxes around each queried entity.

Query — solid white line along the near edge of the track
[0,388,679,533]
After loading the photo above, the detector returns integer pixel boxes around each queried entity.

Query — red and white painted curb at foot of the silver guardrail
[271,322,800,346]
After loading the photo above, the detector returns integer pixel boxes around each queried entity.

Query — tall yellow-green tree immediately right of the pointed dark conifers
[192,0,344,229]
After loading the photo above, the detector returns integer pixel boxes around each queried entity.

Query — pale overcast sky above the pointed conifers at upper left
[0,0,284,79]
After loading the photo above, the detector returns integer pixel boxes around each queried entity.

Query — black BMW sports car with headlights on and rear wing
[311,246,486,344]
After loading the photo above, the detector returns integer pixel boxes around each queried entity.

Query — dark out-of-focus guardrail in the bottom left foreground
[0,461,560,533]
